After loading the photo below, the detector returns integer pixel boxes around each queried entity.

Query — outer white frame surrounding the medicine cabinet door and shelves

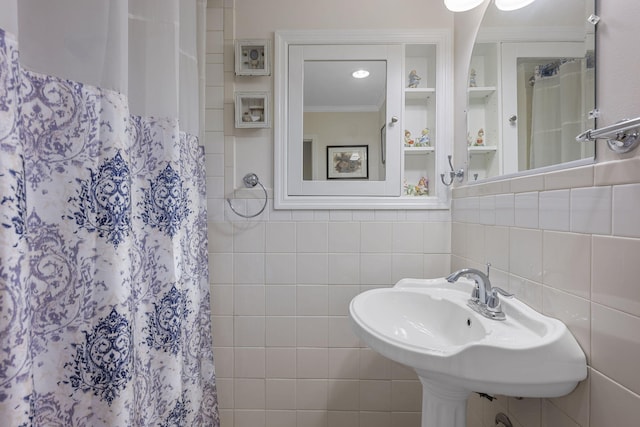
[274,30,453,209]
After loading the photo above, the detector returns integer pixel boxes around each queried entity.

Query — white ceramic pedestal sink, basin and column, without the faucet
[350,278,587,427]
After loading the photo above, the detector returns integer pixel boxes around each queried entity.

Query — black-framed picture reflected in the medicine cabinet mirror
[327,145,369,179]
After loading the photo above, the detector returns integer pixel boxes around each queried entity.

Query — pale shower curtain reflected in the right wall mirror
[529,59,594,168]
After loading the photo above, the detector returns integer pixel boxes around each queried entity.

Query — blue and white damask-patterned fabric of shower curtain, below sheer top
[0,30,219,427]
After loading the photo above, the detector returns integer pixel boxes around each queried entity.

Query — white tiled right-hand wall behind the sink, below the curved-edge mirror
[451,159,640,427]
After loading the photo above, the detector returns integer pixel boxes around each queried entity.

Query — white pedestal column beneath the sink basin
[419,376,471,427]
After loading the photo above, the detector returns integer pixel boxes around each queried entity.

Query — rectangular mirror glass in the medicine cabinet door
[302,60,387,181]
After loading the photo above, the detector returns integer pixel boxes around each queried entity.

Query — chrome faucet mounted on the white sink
[447,264,513,320]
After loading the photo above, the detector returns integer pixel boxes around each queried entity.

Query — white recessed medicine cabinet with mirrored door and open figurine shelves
[274,30,453,209]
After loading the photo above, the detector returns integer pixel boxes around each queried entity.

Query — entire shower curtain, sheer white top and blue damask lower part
[0,0,219,427]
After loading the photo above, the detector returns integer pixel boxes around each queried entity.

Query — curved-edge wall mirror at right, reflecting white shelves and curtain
[467,0,595,180]
